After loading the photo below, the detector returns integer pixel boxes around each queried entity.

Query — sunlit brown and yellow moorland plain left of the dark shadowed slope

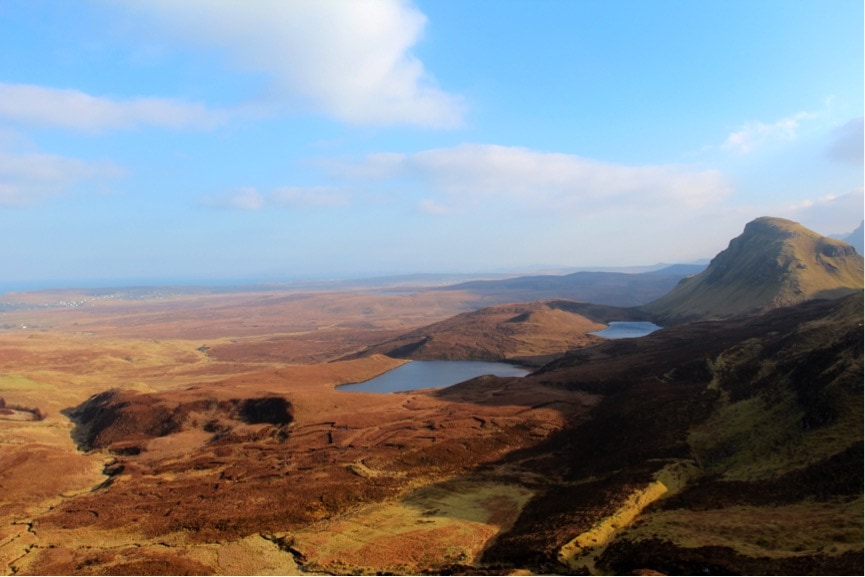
[0,286,595,574]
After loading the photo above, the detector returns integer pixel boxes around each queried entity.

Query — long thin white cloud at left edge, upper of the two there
[0,83,222,132]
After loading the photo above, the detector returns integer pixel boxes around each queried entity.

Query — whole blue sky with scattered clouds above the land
[0,0,865,288]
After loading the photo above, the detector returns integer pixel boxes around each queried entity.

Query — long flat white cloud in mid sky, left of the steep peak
[339,144,731,213]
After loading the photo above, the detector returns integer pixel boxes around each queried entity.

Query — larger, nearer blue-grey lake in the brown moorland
[337,361,530,393]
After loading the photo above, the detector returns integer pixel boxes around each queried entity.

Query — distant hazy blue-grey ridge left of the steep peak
[439,265,705,307]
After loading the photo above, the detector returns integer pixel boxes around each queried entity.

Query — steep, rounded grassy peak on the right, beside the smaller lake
[641,217,863,324]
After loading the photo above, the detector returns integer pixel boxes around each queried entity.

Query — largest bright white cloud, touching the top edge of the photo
[126,0,463,127]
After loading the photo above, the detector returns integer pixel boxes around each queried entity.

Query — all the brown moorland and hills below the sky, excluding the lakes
[0,219,863,574]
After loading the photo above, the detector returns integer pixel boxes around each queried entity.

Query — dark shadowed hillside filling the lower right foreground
[448,295,863,575]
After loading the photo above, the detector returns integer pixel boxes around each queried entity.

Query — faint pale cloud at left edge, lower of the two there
[0,149,123,206]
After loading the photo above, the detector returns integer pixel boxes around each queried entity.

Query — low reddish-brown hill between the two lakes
[352,300,648,366]
